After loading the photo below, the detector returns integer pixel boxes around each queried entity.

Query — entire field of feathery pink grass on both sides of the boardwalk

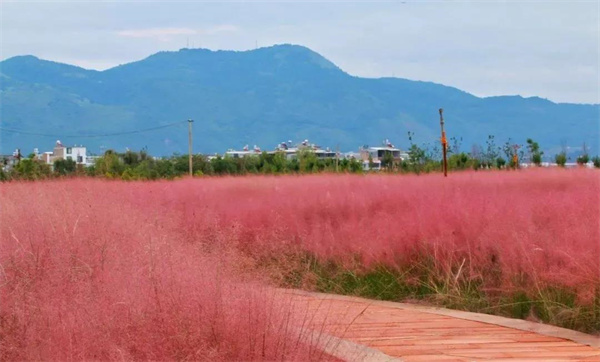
[0,170,600,360]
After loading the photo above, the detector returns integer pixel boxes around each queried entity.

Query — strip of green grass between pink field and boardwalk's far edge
[278,255,600,334]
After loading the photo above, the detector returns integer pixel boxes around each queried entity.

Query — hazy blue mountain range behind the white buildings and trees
[0,45,600,155]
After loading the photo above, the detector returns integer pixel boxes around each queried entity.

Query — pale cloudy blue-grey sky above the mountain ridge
[0,0,600,103]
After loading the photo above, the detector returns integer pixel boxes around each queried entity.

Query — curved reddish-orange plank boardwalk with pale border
[286,290,600,362]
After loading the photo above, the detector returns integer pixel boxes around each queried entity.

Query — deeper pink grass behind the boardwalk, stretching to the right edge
[146,170,600,294]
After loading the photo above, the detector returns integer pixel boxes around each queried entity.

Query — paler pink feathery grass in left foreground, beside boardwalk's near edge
[0,180,326,361]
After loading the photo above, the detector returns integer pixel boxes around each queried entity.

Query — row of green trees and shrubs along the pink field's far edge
[0,133,600,181]
